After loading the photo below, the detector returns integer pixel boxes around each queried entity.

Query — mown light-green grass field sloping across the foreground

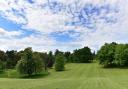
[0,63,128,89]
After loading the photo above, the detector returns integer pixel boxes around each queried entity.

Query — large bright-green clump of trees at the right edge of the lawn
[96,42,128,67]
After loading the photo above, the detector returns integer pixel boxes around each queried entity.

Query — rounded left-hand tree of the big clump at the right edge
[97,42,117,67]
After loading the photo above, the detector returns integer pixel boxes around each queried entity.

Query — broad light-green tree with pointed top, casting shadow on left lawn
[16,47,43,76]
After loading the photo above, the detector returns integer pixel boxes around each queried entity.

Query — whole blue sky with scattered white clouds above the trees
[0,0,128,52]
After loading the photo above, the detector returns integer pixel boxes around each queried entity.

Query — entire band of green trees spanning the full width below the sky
[0,42,128,75]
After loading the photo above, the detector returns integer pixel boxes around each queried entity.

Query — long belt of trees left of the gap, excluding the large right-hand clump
[0,47,94,76]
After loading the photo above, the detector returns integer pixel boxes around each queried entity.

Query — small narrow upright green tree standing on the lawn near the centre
[55,54,66,71]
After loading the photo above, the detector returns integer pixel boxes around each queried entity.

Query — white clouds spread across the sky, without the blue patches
[0,0,128,50]
